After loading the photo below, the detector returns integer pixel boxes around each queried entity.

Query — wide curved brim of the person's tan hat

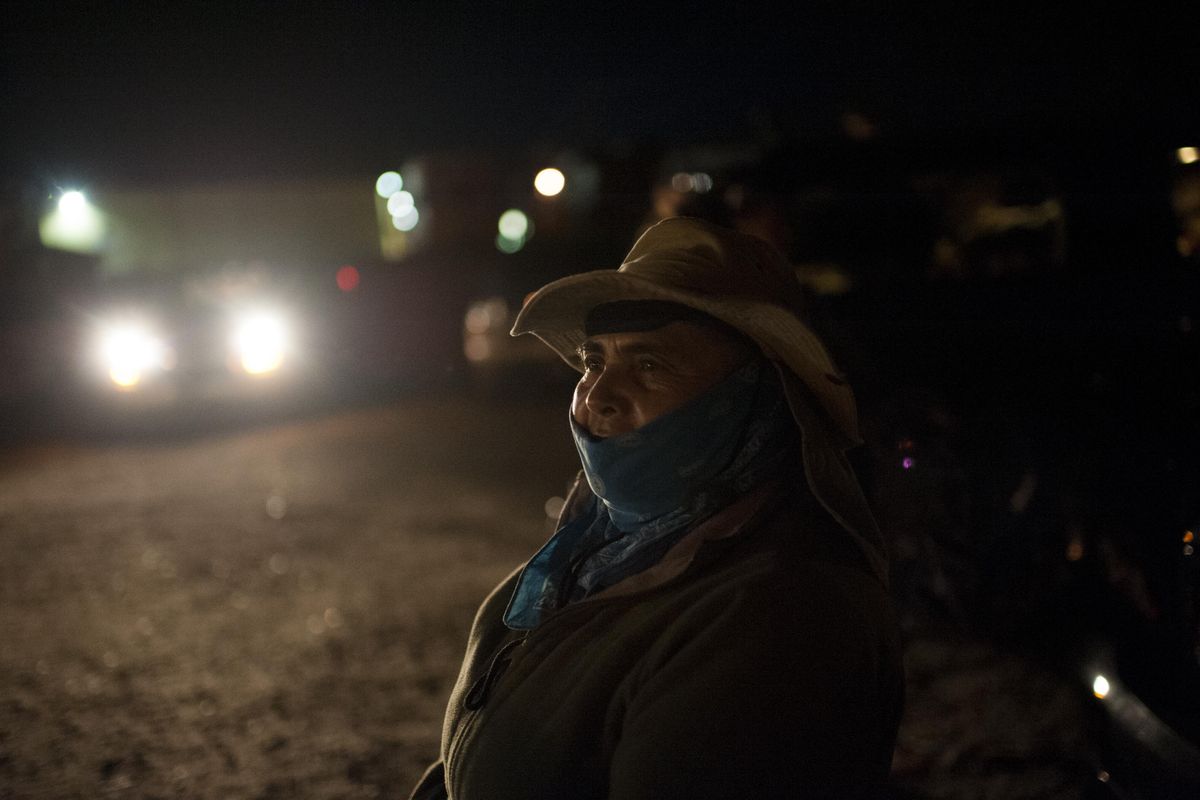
[511,270,862,444]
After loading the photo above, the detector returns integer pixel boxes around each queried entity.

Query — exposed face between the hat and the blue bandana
[571,323,750,439]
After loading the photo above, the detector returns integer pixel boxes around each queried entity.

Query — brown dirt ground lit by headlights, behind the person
[0,399,1088,799]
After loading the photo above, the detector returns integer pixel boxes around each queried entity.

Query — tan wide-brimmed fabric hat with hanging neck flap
[512,217,887,582]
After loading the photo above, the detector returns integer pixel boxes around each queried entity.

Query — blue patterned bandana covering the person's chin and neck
[504,360,799,630]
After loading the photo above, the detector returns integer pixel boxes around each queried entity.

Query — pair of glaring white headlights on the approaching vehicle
[100,309,289,390]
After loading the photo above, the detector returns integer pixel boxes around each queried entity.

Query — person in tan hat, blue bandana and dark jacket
[413,217,902,800]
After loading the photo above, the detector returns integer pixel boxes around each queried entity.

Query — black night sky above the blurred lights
[0,2,1200,182]
